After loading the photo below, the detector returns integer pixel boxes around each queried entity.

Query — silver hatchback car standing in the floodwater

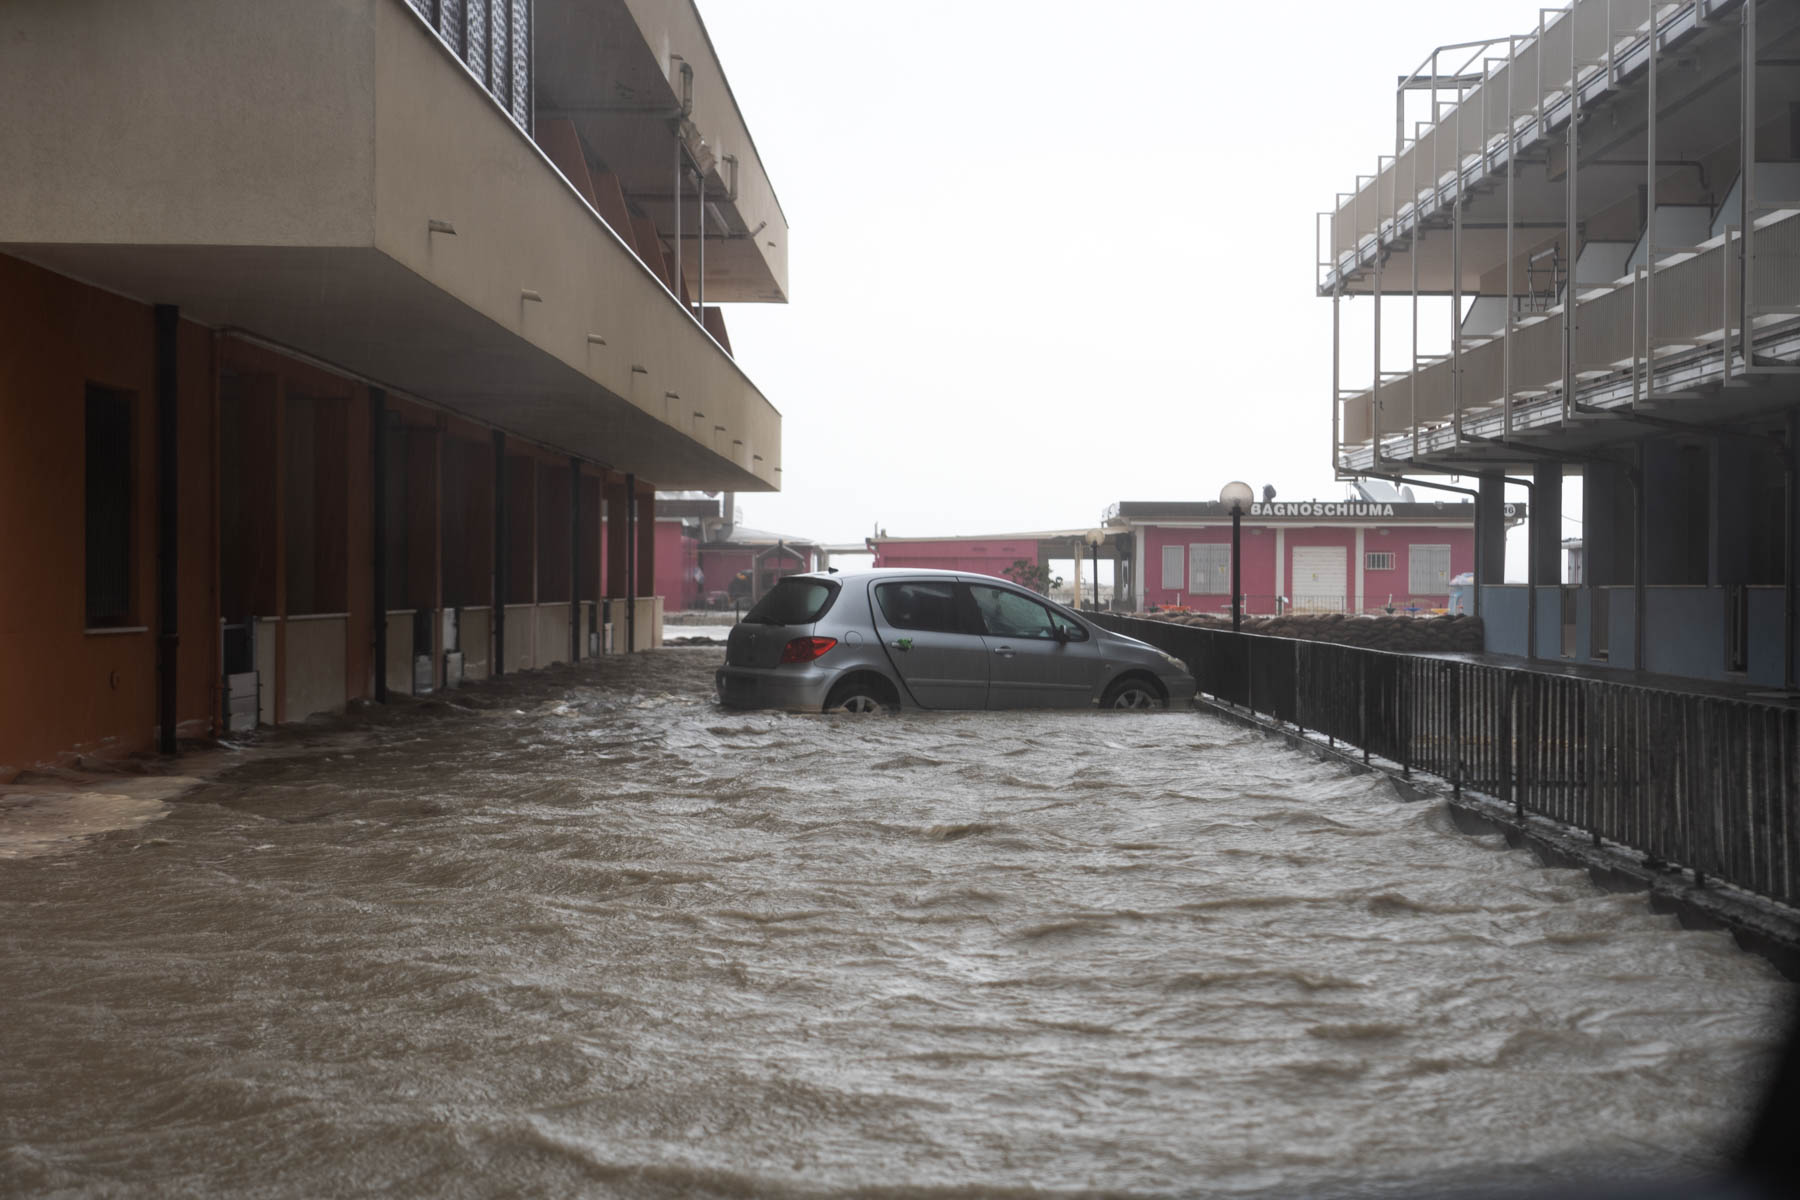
[716,569,1193,712]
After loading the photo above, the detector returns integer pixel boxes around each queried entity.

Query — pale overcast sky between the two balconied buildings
[698,0,1537,542]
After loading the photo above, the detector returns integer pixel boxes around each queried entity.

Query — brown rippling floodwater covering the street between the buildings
[0,648,1793,1196]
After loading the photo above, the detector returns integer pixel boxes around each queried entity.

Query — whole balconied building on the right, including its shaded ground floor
[1318,0,1800,687]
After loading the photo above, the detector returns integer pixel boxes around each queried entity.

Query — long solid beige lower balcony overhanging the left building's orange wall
[0,0,785,491]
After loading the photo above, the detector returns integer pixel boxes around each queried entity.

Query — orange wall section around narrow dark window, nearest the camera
[0,255,216,770]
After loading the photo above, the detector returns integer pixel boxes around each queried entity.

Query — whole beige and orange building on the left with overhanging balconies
[0,0,787,770]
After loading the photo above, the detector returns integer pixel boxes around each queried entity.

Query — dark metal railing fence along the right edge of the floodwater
[1089,613,1800,905]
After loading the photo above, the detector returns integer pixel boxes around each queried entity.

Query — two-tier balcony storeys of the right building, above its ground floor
[1318,0,1800,475]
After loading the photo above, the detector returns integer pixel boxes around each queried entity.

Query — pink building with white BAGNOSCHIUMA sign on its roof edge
[1107,500,1525,615]
